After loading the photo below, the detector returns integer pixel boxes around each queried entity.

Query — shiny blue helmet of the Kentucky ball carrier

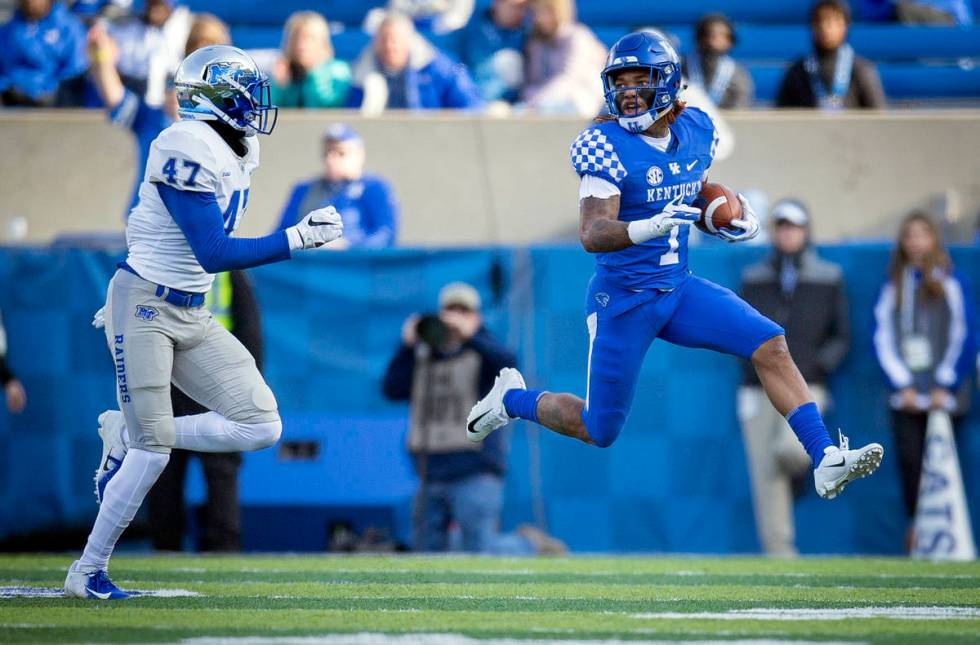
[602,31,681,133]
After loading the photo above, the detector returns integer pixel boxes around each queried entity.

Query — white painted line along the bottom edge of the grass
[179,629,855,645]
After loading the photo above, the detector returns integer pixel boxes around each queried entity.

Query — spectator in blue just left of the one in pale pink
[463,0,529,103]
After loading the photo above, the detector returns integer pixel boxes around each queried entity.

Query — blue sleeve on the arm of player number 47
[157,184,290,273]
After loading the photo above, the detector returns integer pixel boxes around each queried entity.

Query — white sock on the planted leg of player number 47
[78,449,170,571]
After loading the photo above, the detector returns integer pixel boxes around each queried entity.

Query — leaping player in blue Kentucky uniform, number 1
[467,32,883,499]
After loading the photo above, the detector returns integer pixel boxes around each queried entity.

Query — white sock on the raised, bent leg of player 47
[174,412,282,452]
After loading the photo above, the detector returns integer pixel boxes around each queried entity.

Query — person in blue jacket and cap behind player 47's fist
[278,123,398,250]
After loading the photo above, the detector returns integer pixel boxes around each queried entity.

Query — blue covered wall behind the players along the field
[0,245,980,554]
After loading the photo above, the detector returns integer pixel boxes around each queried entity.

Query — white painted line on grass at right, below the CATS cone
[631,607,980,621]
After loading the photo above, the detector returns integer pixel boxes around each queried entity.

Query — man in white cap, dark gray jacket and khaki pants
[738,200,850,558]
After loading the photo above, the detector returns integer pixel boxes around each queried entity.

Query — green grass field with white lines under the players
[0,555,980,645]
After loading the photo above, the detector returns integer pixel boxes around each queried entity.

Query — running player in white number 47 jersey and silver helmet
[65,45,343,599]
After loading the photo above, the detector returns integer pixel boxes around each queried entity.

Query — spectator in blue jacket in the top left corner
[0,0,86,107]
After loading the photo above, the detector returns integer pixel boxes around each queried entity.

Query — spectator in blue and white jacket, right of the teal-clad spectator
[348,13,483,114]
